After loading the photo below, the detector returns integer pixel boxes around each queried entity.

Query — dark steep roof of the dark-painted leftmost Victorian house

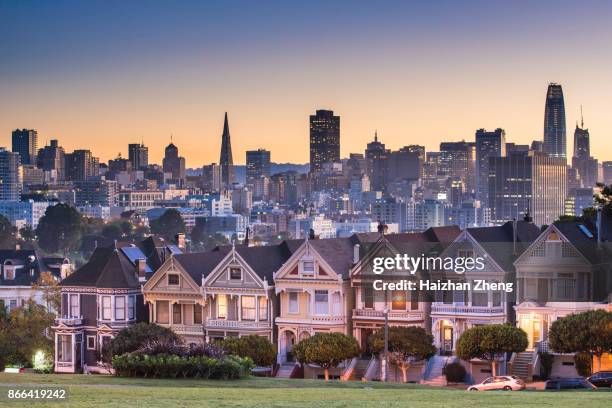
[61,247,140,289]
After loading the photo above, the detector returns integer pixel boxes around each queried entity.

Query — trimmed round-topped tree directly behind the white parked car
[457,324,529,375]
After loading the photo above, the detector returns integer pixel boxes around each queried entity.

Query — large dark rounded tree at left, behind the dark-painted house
[36,204,83,255]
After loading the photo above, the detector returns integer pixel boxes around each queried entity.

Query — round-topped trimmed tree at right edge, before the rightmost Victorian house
[548,310,612,372]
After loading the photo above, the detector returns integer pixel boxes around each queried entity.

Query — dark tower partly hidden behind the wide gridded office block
[476,128,506,203]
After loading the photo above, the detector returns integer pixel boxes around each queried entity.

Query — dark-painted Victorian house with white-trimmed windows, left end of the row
[53,245,149,373]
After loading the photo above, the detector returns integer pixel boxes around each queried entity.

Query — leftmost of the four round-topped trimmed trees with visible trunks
[293,333,359,381]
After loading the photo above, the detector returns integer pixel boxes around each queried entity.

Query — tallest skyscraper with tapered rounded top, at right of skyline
[544,83,567,160]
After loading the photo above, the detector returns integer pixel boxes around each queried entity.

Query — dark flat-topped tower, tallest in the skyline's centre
[310,110,340,173]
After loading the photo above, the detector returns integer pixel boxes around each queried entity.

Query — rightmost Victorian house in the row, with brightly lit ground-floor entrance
[513,221,612,378]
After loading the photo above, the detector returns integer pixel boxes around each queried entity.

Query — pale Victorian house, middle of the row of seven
[274,238,354,363]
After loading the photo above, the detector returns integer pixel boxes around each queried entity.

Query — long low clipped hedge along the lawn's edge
[113,353,254,380]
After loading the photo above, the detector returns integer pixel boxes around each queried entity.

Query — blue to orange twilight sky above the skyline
[0,0,612,167]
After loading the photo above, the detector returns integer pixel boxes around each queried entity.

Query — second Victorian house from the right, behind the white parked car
[430,221,540,355]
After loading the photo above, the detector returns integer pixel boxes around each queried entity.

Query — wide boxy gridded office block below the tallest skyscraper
[488,151,567,225]
